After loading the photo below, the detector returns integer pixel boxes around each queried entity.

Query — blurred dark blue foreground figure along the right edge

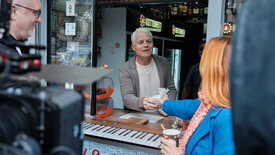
[230,0,275,155]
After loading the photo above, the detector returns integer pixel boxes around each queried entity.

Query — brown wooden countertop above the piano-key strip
[85,109,178,135]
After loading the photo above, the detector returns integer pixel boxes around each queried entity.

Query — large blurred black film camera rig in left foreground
[0,0,84,155]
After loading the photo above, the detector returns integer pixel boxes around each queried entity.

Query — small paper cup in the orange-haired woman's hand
[162,129,180,147]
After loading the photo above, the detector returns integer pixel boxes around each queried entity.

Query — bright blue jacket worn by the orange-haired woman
[162,99,235,155]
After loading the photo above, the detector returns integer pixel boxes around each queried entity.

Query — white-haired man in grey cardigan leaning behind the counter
[119,28,177,115]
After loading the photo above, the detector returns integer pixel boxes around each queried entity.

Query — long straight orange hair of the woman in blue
[200,36,231,108]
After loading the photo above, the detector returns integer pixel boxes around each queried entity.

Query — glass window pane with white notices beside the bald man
[50,0,92,67]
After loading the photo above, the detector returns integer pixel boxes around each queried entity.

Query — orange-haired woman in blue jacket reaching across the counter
[151,36,235,155]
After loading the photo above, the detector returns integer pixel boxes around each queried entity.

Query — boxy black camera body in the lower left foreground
[0,79,84,154]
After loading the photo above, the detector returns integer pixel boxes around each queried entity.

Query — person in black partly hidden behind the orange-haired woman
[182,42,205,99]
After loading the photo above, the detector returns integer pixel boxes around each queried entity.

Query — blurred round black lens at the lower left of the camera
[0,96,35,144]
